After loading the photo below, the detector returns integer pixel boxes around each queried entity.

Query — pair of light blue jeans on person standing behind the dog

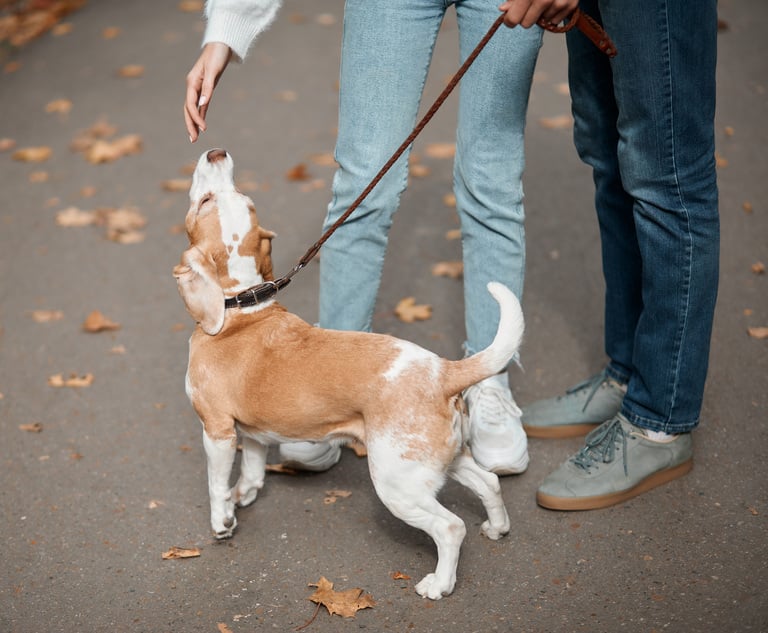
[319,0,542,353]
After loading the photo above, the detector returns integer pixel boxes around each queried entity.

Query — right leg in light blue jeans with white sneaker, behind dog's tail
[454,0,542,474]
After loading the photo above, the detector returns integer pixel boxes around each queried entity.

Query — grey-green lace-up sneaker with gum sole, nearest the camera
[536,415,693,510]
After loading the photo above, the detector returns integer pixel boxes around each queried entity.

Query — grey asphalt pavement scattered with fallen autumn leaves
[0,0,768,633]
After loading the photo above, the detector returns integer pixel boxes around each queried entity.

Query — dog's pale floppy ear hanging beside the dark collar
[173,246,224,336]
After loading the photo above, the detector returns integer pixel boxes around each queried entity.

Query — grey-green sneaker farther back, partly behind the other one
[522,371,627,438]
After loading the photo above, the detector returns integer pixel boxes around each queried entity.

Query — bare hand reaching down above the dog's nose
[184,42,232,143]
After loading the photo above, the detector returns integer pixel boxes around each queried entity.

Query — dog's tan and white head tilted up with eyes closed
[173,149,274,334]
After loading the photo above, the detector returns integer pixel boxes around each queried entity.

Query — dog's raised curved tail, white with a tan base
[445,281,525,393]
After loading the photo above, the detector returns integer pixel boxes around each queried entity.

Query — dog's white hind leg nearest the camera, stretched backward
[368,444,467,600]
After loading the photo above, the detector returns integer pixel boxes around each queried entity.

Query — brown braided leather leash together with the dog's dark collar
[224,9,616,308]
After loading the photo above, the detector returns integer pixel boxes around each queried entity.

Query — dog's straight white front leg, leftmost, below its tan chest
[203,431,237,539]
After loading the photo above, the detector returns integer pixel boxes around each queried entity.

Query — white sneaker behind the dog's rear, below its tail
[464,373,529,475]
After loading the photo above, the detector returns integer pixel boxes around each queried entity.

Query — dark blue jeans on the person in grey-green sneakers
[568,0,720,433]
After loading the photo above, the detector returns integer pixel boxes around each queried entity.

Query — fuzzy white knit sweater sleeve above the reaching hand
[203,0,281,59]
